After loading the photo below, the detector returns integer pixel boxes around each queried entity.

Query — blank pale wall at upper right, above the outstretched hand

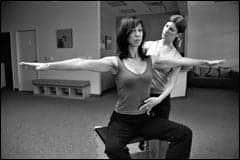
[186,1,239,71]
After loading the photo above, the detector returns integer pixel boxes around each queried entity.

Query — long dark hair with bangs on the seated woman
[117,16,148,60]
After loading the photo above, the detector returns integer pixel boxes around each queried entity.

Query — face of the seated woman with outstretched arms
[128,24,143,47]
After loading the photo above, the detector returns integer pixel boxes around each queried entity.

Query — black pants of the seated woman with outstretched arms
[105,109,192,159]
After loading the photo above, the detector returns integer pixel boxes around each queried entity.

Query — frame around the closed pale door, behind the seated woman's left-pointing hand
[16,28,40,91]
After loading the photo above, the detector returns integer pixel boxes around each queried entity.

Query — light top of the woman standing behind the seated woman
[147,40,182,94]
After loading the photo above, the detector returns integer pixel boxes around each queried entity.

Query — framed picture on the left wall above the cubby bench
[57,29,73,48]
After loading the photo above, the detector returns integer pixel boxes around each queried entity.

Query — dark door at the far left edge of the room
[0,32,13,90]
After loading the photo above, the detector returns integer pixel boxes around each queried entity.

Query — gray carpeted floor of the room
[1,88,239,159]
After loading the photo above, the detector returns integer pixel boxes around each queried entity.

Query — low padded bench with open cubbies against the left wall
[32,79,90,99]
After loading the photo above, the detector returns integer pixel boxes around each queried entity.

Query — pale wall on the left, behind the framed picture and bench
[2,1,101,94]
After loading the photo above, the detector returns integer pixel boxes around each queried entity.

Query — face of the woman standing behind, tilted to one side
[162,22,178,40]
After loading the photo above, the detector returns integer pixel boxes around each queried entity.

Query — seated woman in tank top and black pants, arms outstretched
[19,17,225,159]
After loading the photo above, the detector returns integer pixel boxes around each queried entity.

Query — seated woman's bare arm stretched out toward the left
[20,56,116,73]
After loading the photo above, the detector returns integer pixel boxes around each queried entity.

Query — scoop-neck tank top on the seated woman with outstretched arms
[114,57,152,115]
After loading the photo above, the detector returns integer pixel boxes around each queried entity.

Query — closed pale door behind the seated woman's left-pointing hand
[17,30,38,91]
